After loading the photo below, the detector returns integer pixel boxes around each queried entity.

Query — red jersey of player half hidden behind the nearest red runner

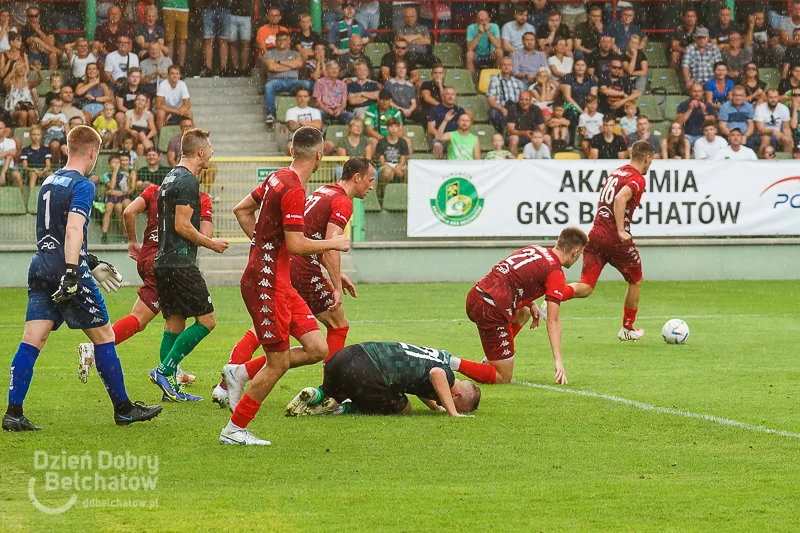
[292,184,353,269]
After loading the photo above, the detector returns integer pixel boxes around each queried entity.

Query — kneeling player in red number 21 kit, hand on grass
[450,228,589,385]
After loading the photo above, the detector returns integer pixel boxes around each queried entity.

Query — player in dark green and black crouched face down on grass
[286,342,481,416]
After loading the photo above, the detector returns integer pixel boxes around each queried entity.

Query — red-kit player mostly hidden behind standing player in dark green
[78,185,214,383]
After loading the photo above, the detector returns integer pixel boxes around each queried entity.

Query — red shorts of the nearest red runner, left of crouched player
[241,285,319,352]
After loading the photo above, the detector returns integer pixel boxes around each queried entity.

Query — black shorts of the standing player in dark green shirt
[153,265,214,318]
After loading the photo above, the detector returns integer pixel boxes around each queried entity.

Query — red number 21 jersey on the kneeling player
[476,246,566,317]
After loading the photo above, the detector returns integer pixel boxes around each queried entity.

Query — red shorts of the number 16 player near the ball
[581,233,642,287]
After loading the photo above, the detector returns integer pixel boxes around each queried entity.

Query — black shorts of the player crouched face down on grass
[322,344,408,415]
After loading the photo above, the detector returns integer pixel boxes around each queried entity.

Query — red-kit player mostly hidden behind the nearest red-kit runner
[211,157,375,409]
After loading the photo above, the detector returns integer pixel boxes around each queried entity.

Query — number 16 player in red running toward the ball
[562,141,654,341]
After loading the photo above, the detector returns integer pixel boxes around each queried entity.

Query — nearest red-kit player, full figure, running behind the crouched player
[219,126,350,446]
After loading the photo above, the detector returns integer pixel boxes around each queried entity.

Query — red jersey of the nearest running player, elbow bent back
[242,167,306,290]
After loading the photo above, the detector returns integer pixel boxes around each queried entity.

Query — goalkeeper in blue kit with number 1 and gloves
[2,126,161,431]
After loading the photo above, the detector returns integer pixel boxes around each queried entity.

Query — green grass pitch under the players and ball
[0,282,800,532]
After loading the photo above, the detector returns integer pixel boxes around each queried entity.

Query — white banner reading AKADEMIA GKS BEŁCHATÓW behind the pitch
[408,159,800,238]
